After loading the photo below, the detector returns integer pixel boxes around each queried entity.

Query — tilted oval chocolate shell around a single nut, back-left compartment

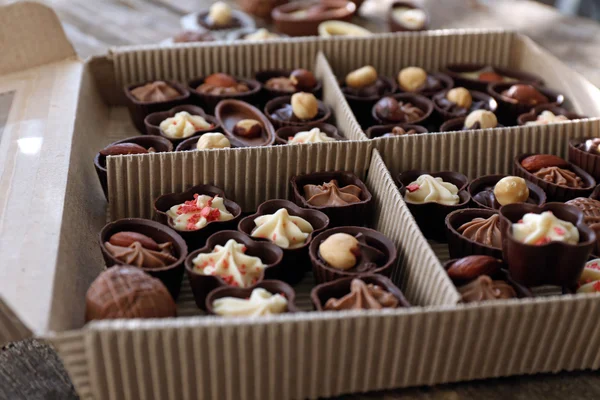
[215,100,275,147]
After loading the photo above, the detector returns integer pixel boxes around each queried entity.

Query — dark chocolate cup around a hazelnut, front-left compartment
[309,226,398,283]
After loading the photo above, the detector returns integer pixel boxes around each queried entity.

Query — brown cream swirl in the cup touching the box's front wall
[324,279,398,311]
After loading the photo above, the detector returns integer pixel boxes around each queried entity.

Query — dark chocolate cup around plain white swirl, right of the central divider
[396,170,471,242]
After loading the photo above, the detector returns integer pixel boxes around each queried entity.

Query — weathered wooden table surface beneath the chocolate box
[0,0,600,400]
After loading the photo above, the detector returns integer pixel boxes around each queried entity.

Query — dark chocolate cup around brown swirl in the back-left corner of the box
[124,81,190,133]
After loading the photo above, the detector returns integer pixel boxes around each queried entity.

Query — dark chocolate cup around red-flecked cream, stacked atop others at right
[500,203,596,287]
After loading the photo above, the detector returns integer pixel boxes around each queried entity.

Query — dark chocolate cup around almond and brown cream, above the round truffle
[98,218,188,300]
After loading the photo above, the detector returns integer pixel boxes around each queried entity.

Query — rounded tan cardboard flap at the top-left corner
[0,2,77,75]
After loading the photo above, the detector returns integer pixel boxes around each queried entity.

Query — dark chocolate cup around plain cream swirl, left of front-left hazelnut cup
[238,199,329,285]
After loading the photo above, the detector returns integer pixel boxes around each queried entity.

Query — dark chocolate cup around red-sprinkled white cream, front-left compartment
[154,185,242,250]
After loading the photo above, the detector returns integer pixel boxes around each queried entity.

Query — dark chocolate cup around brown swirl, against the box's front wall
[310,274,410,311]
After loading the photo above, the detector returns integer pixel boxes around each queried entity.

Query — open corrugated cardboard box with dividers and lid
[0,3,600,399]
